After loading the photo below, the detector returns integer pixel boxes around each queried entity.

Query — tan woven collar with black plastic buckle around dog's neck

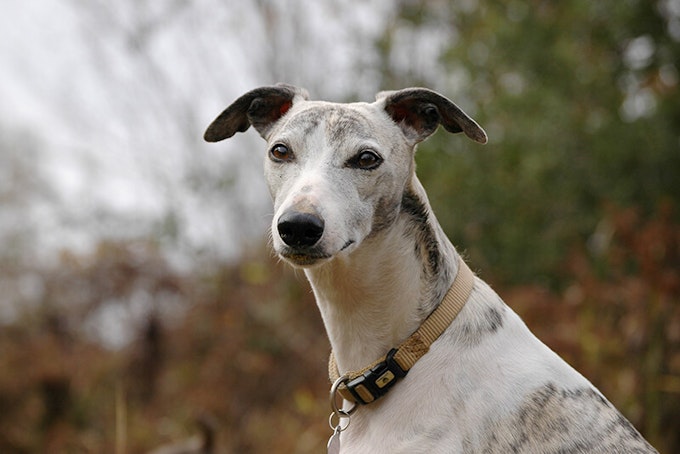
[328,258,475,404]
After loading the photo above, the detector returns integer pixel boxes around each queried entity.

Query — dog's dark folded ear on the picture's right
[376,88,487,143]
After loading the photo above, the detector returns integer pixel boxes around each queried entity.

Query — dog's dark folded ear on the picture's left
[203,84,309,142]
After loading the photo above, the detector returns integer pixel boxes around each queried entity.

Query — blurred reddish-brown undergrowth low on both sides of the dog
[0,207,680,453]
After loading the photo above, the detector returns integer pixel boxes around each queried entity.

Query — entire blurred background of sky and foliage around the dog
[0,0,680,454]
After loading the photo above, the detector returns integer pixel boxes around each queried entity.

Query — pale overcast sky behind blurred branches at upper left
[0,0,390,266]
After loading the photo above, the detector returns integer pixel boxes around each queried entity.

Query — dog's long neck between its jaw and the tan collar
[305,176,458,373]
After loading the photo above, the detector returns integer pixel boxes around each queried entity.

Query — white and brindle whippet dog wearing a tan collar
[204,85,656,454]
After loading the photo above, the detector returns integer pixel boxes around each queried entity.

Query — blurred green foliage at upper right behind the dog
[382,0,680,285]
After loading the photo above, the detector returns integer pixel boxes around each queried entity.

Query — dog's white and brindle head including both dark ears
[204,85,487,267]
